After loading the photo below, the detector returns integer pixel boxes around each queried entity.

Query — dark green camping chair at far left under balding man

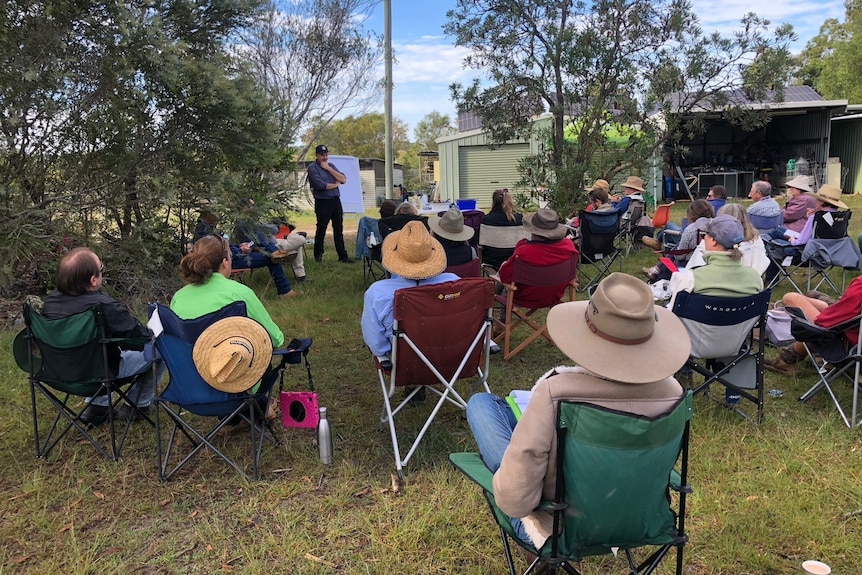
[12,304,153,460]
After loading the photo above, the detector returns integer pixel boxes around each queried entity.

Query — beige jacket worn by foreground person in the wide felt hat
[494,366,683,548]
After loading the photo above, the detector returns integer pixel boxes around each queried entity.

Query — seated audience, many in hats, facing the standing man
[30,176,862,512]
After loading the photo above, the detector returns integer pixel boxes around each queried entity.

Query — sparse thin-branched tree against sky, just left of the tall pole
[240,0,382,158]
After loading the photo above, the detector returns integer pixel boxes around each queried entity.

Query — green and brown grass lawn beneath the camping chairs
[0,197,862,575]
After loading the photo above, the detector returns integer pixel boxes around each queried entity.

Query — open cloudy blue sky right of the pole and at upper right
[366,0,844,137]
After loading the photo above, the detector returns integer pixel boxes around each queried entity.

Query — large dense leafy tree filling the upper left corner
[0,0,279,300]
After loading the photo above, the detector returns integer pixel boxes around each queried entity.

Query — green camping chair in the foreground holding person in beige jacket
[449,391,692,575]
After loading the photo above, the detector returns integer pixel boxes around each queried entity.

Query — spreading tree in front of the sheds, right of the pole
[444,0,793,211]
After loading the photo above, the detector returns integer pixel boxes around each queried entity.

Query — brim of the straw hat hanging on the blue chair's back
[192,316,272,393]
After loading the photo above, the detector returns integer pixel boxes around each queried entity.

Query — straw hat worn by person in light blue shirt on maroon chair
[382,221,446,280]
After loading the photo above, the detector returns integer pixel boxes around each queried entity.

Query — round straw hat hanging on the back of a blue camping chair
[192,316,272,393]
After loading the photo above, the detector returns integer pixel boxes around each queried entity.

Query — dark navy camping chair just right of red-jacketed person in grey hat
[578,210,623,291]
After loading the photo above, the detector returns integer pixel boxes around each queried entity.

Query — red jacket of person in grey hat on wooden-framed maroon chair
[499,237,578,308]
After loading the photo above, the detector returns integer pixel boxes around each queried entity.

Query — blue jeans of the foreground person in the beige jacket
[467,393,532,545]
